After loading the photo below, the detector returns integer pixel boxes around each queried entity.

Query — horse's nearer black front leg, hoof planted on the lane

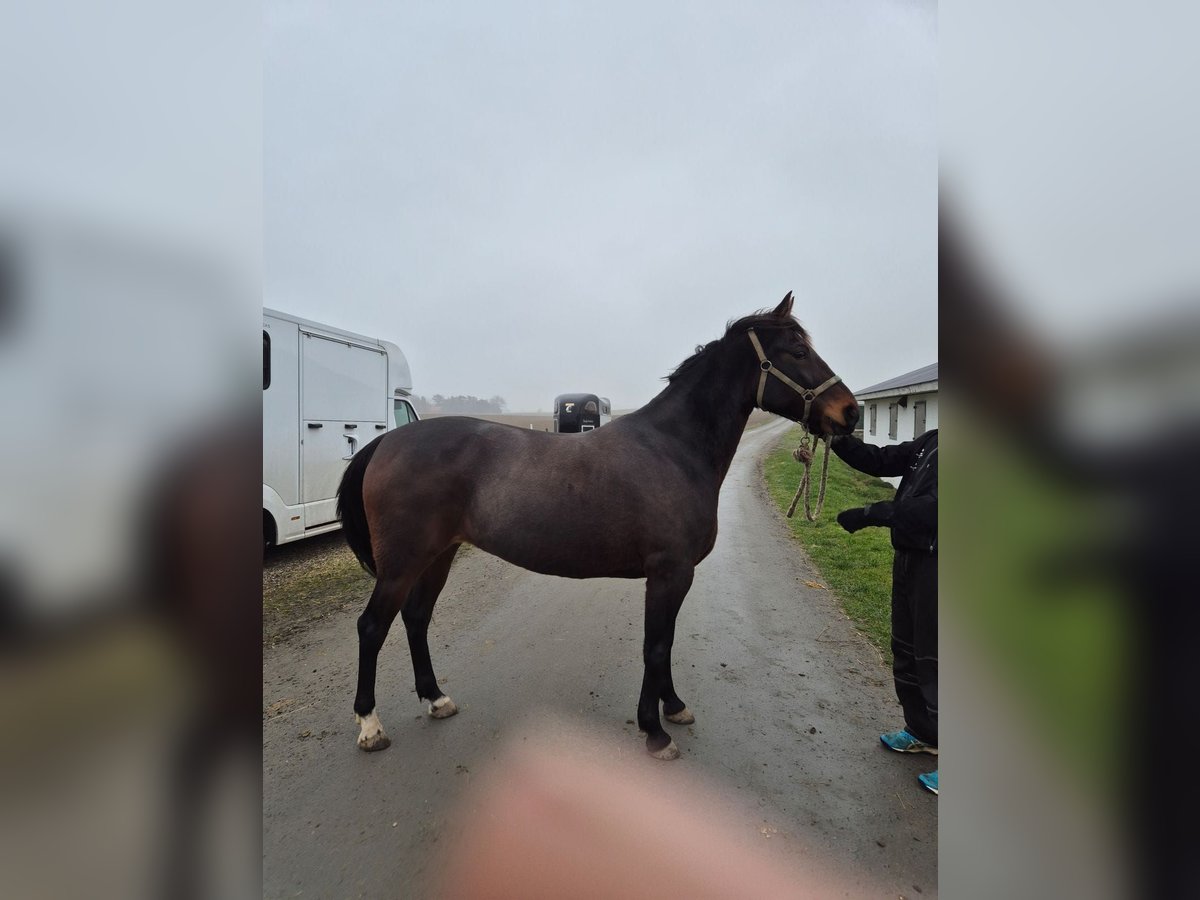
[637,565,694,760]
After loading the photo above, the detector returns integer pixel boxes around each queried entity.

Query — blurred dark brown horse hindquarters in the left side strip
[146,427,262,898]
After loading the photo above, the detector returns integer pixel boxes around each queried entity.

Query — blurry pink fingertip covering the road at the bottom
[438,714,868,900]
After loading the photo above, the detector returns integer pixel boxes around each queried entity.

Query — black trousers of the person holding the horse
[892,550,937,746]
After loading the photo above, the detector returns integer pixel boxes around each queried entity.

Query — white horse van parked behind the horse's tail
[263,308,418,545]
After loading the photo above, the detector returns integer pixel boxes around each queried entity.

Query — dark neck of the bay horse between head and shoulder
[641,350,754,485]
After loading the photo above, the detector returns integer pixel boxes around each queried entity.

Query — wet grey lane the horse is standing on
[263,422,937,898]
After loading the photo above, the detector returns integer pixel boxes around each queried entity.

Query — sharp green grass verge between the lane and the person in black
[763,427,895,665]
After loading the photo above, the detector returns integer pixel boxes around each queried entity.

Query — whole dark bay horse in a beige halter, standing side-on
[338,293,858,760]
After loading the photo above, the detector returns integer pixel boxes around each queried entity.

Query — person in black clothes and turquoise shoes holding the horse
[832,428,937,793]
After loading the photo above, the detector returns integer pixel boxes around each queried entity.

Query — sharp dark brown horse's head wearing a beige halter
[746,292,858,434]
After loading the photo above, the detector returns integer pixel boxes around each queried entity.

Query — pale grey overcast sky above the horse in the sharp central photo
[263,0,937,412]
